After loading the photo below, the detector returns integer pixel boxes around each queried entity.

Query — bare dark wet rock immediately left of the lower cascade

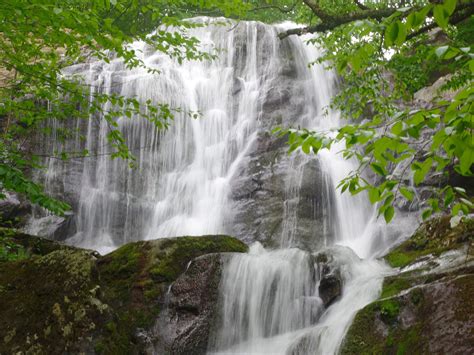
[155,254,230,354]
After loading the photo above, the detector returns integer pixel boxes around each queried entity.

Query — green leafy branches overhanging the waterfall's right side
[277,0,474,222]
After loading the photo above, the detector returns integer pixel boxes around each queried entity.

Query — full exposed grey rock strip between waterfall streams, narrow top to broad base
[230,34,335,250]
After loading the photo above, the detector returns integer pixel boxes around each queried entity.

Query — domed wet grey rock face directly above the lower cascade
[231,138,336,250]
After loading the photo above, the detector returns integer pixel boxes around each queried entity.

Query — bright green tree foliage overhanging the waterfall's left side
[0,0,247,214]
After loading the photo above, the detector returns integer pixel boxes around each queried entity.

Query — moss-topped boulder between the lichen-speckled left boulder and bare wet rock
[96,235,247,354]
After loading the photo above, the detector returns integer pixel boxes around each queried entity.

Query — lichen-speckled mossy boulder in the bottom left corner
[0,246,104,353]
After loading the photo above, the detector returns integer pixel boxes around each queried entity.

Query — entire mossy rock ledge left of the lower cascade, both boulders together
[0,230,247,354]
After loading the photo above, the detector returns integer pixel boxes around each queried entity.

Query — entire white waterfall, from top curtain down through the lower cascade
[30,18,414,355]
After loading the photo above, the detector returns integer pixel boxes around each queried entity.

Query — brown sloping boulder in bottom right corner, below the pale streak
[341,267,474,354]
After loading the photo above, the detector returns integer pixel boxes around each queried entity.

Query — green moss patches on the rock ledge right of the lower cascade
[341,216,474,355]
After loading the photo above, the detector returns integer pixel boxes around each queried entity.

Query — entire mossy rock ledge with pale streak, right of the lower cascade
[341,216,474,355]
